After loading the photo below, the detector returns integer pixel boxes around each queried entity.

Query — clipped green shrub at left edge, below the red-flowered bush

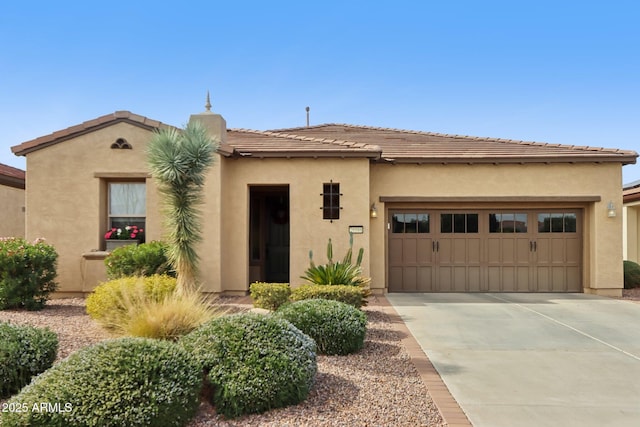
[0,322,58,398]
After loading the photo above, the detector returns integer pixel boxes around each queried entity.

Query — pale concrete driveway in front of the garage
[386,293,640,427]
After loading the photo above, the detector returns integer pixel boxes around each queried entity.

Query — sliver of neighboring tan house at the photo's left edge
[0,163,25,237]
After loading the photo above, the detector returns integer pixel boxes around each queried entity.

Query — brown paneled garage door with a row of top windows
[388,209,582,292]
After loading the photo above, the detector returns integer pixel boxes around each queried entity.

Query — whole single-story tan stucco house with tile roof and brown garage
[12,106,637,296]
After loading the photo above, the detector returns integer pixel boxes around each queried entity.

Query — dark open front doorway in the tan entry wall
[249,186,289,283]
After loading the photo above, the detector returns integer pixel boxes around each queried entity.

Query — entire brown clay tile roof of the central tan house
[11,111,638,164]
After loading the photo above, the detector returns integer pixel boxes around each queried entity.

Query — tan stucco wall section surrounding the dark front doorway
[210,159,371,292]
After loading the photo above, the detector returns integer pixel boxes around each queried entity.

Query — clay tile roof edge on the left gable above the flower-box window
[11,111,170,156]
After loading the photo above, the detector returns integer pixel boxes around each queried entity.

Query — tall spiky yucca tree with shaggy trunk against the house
[147,121,218,293]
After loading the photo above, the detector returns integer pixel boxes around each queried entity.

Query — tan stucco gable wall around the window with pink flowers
[26,123,161,293]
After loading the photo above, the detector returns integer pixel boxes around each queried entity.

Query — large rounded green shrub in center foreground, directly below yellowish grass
[179,313,317,417]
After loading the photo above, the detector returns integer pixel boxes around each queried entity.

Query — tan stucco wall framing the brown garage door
[371,163,623,294]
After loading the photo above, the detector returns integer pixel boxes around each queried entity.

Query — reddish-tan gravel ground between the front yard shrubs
[0,297,446,427]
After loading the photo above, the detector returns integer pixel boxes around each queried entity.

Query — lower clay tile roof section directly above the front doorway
[227,129,381,158]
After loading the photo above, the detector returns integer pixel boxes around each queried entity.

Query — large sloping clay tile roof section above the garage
[264,123,638,164]
